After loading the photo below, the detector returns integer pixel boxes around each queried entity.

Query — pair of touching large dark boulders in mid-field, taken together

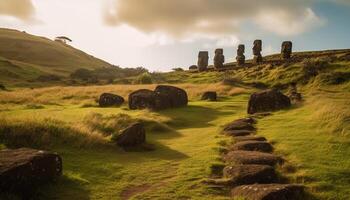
[129,85,188,110]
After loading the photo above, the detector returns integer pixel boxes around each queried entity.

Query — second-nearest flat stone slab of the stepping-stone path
[223,165,278,186]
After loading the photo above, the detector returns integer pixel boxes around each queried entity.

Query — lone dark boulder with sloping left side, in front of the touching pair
[115,123,146,147]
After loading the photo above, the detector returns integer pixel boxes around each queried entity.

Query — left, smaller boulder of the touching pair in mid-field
[128,89,157,110]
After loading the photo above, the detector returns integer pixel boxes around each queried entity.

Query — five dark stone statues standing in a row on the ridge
[198,40,293,71]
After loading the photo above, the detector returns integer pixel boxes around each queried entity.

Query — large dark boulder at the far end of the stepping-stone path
[248,89,291,114]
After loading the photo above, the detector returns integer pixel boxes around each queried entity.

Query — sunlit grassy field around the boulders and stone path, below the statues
[0,46,350,200]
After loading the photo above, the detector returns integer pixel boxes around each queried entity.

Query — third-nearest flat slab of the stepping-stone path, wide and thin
[223,151,283,166]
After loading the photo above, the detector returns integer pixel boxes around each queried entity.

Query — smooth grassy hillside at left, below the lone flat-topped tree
[0,28,111,85]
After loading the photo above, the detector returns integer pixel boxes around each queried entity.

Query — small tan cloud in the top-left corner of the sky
[0,0,35,21]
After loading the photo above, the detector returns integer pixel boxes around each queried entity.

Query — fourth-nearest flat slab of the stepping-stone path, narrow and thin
[230,140,273,153]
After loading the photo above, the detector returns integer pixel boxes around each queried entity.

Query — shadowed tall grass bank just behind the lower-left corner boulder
[0,118,107,148]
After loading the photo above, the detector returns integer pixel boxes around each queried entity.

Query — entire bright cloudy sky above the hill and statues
[0,0,350,71]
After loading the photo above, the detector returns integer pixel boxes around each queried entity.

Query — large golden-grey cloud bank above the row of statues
[104,0,321,37]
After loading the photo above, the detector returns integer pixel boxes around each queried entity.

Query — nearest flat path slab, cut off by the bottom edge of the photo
[231,184,304,200]
